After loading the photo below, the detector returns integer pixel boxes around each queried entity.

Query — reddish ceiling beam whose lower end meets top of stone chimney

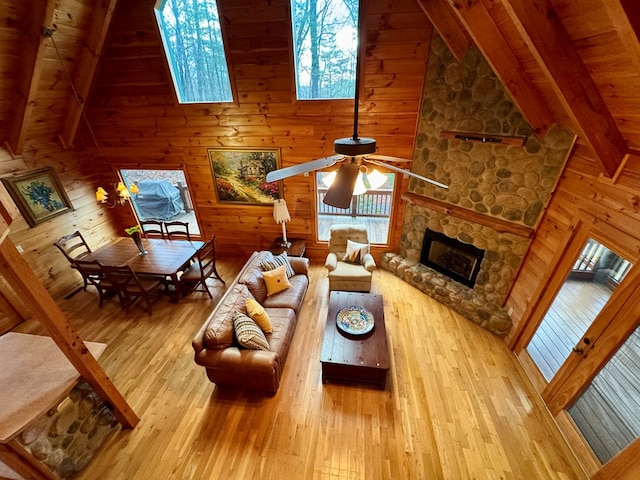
[446,0,555,136]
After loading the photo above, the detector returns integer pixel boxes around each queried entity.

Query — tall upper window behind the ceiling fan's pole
[291,0,358,100]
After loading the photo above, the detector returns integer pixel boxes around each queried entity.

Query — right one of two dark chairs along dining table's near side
[101,265,166,315]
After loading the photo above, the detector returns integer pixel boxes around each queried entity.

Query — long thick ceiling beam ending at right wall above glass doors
[498,0,627,177]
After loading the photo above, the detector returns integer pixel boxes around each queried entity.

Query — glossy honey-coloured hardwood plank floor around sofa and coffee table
[12,259,586,480]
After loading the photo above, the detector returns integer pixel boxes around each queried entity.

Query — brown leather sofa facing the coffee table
[192,251,309,393]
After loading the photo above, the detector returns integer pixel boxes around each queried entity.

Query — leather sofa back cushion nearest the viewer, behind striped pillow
[202,284,251,350]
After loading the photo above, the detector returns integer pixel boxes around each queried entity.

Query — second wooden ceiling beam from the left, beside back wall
[60,0,117,147]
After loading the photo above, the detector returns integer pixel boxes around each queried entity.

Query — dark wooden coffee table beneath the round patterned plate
[320,292,389,389]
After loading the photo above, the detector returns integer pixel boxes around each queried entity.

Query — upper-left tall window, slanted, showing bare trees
[155,0,233,103]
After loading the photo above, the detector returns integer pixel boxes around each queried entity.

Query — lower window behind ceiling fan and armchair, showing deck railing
[316,170,396,245]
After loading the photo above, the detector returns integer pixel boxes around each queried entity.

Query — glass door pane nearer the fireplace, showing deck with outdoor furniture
[526,238,632,382]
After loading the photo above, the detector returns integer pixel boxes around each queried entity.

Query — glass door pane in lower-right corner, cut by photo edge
[568,327,640,464]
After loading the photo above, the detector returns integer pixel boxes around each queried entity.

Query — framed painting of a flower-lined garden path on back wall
[208,148,282,205]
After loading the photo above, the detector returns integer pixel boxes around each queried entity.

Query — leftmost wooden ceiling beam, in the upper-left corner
[7,0,57,155]
